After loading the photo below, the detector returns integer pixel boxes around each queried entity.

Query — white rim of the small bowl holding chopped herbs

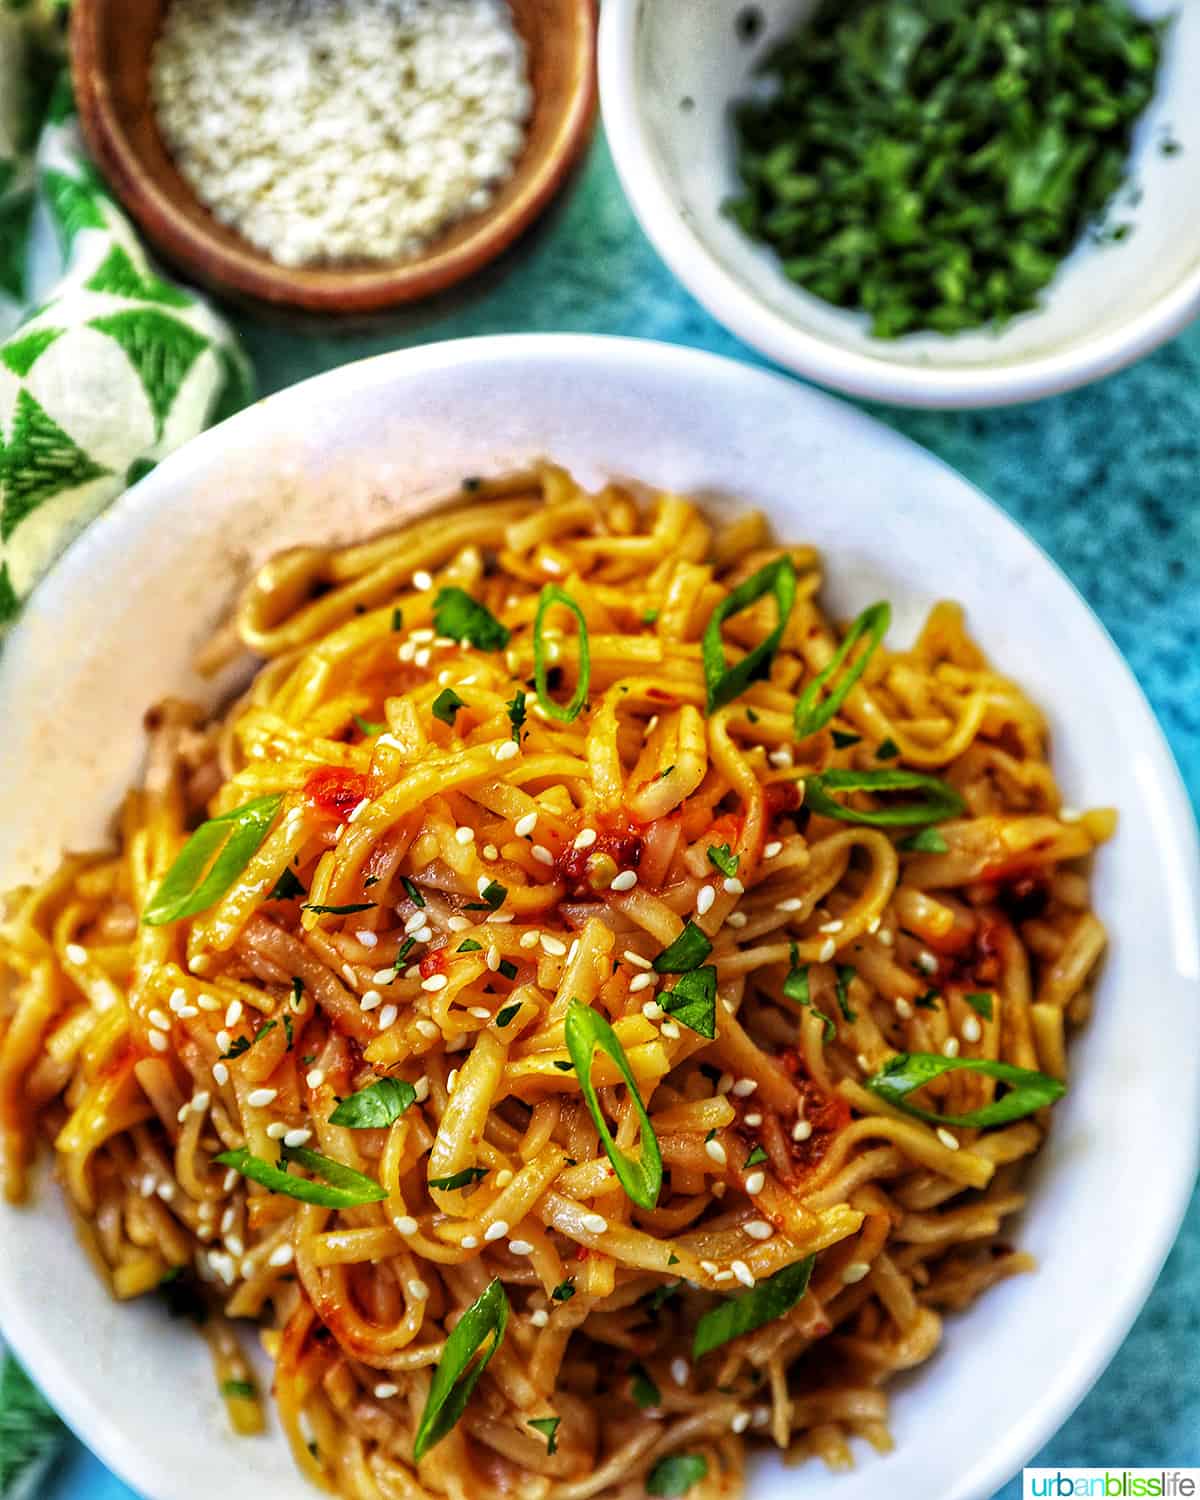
[599,0,1200,410]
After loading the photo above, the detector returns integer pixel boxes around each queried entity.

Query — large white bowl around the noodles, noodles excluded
[0,338,1200,1500]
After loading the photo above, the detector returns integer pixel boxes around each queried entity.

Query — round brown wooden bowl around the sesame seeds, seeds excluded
[71,0,596,315]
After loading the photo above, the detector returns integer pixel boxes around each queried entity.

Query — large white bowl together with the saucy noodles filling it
[0,338,1200,1500]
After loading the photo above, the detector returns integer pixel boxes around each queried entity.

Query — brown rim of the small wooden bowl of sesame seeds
[71,0,597,314]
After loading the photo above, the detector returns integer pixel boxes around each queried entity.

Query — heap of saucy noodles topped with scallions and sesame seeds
[0,468,1115,1500]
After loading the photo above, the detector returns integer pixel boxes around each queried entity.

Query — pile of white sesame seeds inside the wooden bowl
[150,0,533,266]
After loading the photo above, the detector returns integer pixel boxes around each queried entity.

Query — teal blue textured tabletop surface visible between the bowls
[42,138,1200,1500]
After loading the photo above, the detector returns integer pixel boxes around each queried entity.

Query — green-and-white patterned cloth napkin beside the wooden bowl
[0,0,252,633]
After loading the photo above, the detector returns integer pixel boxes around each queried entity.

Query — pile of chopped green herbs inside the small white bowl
[726,0,1166,339]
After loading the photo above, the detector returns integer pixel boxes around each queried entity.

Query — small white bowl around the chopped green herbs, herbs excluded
[600,0,1200,407]
